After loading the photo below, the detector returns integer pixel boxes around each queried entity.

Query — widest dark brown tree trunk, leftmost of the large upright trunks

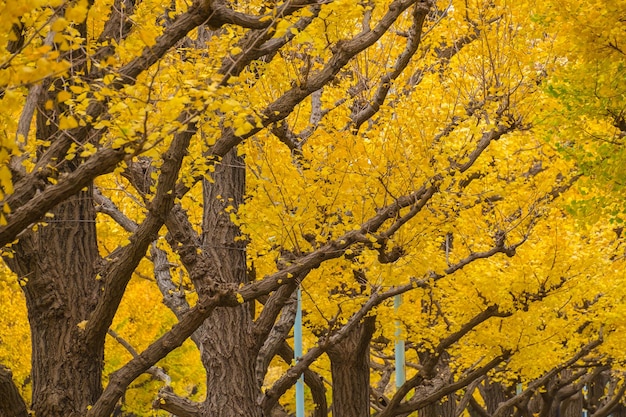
[7,189,104,417]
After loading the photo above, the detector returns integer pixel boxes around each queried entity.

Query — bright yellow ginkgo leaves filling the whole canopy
[0,0,626,413]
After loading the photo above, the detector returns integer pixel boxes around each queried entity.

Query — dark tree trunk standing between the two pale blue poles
[328,317,376,417]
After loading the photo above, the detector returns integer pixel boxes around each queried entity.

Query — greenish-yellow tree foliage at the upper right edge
[538,1,626,224]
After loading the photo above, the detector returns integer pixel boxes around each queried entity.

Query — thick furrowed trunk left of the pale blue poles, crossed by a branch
[200,149,261,417]
